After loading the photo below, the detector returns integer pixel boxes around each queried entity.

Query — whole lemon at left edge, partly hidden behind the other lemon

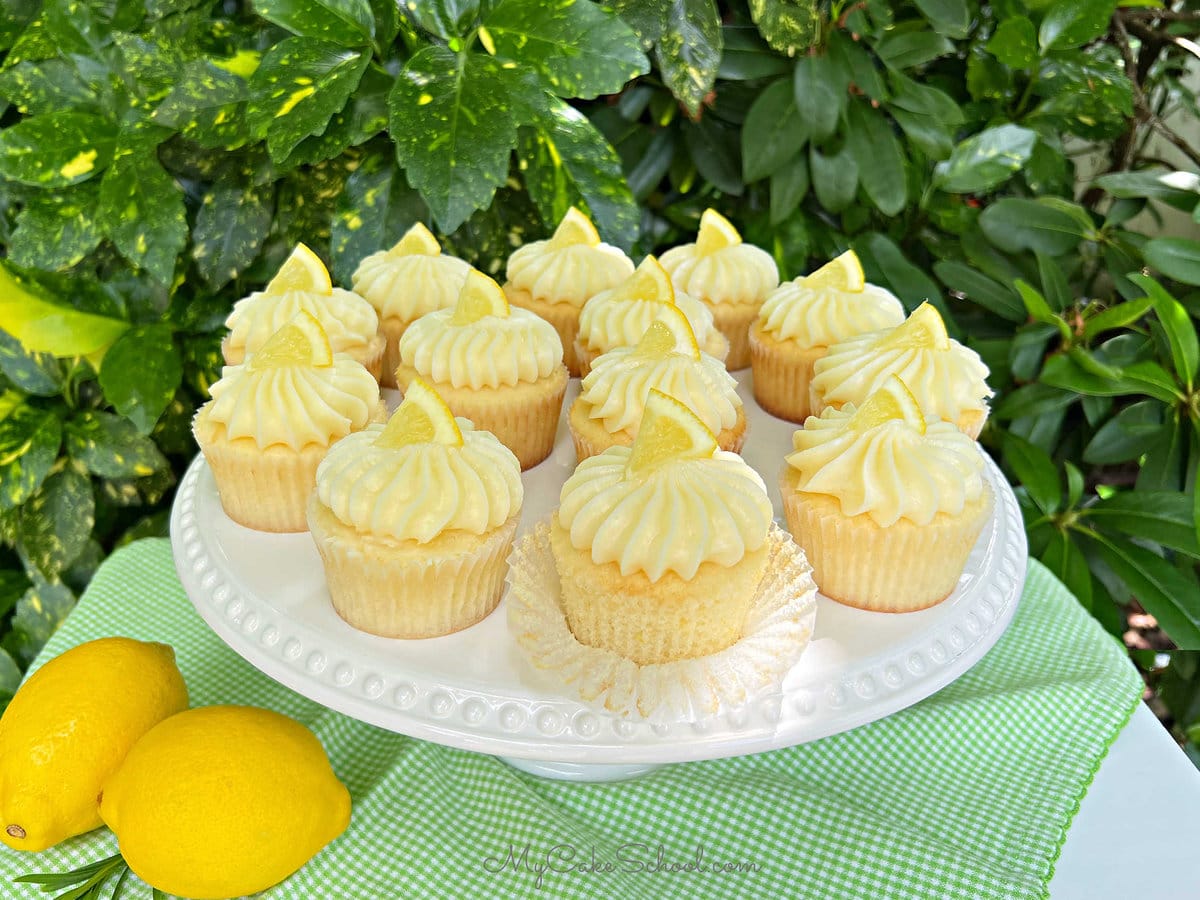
[0,637,187,851]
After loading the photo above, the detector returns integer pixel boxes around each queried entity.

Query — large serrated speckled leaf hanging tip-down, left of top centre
[388,47,530,232]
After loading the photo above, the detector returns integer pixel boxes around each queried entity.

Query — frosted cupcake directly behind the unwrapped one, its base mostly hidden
[568,304,746,461]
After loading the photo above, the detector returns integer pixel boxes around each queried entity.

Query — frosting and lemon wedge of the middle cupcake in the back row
[505,206,634,307]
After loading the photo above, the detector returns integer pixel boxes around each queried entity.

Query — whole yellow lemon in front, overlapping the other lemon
[100,706,350,900]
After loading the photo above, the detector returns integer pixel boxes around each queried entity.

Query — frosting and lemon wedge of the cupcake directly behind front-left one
[400,270,563,390]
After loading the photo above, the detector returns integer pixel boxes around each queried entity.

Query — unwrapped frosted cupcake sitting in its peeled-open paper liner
[550,391,772,666]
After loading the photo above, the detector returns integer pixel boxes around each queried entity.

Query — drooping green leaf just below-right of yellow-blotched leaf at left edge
[98,151,187,284]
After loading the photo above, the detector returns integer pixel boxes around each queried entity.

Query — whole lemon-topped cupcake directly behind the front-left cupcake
[395,270,568,469]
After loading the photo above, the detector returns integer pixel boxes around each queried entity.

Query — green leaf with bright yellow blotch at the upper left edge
[0,110,116,187]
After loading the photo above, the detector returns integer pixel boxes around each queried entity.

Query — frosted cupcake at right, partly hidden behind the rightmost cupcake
[750,250,904,422]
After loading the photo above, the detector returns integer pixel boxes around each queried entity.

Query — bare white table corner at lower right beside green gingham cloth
[1050,704,1200,900]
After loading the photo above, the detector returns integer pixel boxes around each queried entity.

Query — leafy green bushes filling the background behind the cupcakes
[0,0,1200,763]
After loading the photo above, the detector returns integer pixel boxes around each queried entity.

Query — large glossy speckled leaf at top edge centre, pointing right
[482,0,648,100]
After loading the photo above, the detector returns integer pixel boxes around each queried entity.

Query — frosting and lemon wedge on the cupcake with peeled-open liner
[558,391,772,582]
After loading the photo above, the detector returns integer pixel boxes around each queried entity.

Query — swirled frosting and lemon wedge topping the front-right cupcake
[787,376,984,528]
